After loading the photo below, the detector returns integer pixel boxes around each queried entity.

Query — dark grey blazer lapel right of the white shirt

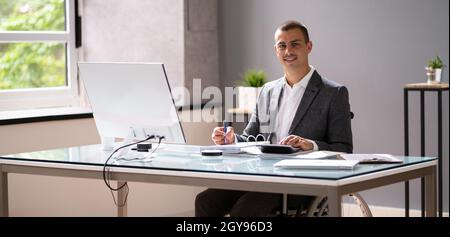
[289,71,322,134]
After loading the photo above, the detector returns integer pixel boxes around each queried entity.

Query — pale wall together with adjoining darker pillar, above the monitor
[82,0,219,105]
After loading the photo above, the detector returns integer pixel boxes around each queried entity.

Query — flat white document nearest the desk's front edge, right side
[273,159,358,170]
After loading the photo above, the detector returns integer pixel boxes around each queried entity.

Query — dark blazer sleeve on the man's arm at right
[315,86,353,153]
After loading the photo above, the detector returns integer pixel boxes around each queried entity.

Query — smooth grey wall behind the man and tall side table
[219,0,449,211]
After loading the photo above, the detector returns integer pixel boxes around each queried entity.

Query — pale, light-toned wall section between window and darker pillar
[82,0,184,90]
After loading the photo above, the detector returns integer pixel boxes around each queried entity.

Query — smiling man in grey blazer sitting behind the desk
[195,21,353,216]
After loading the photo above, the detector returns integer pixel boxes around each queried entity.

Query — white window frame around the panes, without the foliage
[0,0,80,111]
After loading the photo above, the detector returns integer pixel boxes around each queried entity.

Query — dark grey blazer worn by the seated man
[237,71,353,153]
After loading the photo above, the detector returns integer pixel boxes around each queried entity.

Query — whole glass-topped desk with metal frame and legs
[0,144,437,216]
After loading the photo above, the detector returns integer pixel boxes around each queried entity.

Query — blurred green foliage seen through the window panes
[0,0,66,90]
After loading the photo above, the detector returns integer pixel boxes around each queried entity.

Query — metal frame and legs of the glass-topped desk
[0,158,437,216]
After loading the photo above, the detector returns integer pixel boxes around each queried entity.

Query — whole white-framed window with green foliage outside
[0,0,78,111]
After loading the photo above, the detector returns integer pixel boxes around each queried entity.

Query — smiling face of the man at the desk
[275,29,312,69]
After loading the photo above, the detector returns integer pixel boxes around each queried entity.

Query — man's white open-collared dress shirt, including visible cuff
[275,66,319,151]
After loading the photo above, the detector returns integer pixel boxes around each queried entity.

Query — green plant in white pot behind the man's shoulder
[238,69,267,111]
